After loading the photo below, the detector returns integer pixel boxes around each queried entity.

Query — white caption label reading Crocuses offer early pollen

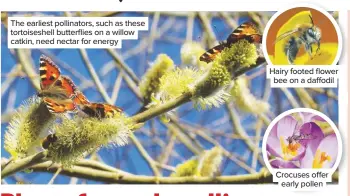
[273,169,332,191]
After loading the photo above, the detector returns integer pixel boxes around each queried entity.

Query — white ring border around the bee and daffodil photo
[262,3,343,65]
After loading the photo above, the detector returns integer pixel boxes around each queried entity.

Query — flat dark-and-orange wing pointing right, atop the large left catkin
[82,103,123,118]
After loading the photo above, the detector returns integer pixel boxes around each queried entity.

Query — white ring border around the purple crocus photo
[262,108,343,174]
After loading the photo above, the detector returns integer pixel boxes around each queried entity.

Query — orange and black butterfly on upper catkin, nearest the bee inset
[199,22,262,63]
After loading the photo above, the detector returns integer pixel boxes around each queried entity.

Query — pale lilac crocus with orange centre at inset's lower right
[300,134,338,169]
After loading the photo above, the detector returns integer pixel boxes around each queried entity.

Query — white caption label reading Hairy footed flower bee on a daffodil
[266,65,339,88]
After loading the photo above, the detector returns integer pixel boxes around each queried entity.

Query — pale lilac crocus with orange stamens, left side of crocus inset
[267,116,305,161]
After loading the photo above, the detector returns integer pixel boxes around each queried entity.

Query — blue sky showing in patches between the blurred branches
[1,12,338,184]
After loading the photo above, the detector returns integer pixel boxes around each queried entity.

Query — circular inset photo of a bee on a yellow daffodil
[263,6,342,65]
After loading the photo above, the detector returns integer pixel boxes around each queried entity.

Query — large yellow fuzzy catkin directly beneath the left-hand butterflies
[48,113,133,167]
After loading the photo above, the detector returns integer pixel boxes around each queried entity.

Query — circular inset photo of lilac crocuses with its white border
[263,108,342,170]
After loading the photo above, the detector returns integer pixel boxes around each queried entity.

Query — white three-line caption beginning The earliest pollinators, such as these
[8,17,148,48]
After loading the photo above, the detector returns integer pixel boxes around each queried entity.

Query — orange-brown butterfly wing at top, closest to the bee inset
[226,22,262,45]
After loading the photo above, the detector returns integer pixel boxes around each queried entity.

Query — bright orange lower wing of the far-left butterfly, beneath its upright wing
[43,97,77,114]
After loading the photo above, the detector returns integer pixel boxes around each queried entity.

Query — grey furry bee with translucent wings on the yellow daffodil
[275,15,322,65]
